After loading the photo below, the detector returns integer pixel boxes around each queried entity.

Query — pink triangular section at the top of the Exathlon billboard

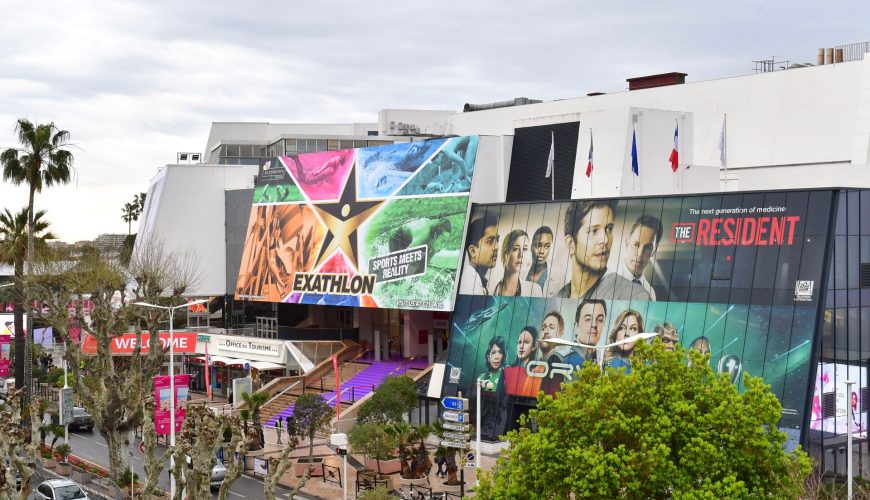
[281,149,356,201]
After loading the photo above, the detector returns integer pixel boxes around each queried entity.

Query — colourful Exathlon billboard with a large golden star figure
[236,136,478,311]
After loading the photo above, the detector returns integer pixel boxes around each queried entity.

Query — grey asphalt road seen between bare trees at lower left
[59,429,289,499]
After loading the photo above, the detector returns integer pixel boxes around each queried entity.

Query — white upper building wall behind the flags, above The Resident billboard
[451,57,870,196]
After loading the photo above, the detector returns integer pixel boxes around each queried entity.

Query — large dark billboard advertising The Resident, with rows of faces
[443,191,834,444]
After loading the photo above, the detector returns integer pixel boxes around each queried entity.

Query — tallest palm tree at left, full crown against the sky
[0,118,73,410]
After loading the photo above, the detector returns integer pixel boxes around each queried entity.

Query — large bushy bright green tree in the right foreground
[477,340,811,499]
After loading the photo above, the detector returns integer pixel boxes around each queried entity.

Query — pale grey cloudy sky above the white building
[0,0,870,241]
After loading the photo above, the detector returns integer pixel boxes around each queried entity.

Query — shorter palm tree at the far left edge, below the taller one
[0,207,54,394]
